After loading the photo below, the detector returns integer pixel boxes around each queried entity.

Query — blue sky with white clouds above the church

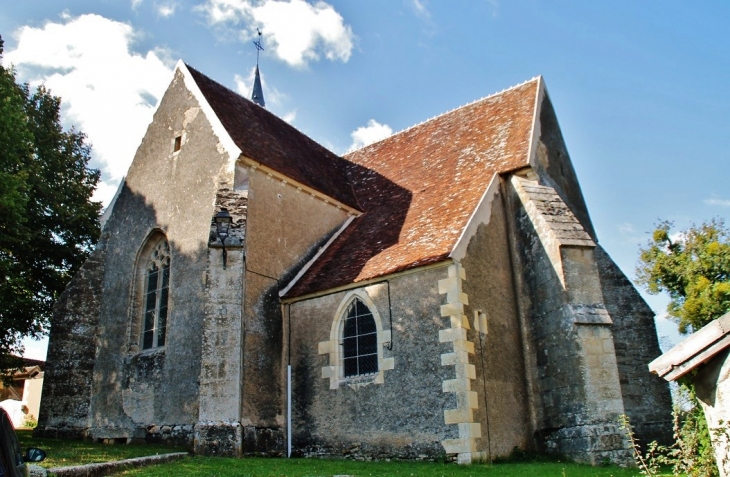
[0,0,730,352]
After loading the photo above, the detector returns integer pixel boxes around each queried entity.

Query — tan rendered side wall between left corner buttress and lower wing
[236,168,348,455]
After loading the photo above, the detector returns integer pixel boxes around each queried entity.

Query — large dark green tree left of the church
[0,37,101,369]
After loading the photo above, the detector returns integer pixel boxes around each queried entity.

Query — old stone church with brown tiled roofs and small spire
[36,62,671,463]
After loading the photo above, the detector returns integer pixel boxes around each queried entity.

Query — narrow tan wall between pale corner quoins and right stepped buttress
[462,188,533,459]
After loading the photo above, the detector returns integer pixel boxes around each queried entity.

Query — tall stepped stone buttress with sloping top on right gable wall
[510,173,631,464]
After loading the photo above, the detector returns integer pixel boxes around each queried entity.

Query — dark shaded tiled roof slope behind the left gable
[185,65,359,209]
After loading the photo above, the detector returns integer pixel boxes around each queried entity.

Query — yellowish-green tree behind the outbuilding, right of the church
[636,218,730,333]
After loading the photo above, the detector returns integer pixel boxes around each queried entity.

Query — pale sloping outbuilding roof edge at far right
[649,313,730,381]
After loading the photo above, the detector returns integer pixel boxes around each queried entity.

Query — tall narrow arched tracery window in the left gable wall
[142,239,170,349]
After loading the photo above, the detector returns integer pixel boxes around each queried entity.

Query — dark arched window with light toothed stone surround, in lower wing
[342,298,378,377]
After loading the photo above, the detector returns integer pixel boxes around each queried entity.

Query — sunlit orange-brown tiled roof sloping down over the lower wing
[287,79,539,297]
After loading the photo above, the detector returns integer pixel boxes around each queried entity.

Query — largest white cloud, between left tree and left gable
[4,15,172,203]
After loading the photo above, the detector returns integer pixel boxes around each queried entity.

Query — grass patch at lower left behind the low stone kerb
[16,429,185,468]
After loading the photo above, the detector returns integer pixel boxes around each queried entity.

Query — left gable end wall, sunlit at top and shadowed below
[83,72,233,445]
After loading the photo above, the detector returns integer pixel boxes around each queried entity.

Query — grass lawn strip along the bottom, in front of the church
[115,457,656,477]
